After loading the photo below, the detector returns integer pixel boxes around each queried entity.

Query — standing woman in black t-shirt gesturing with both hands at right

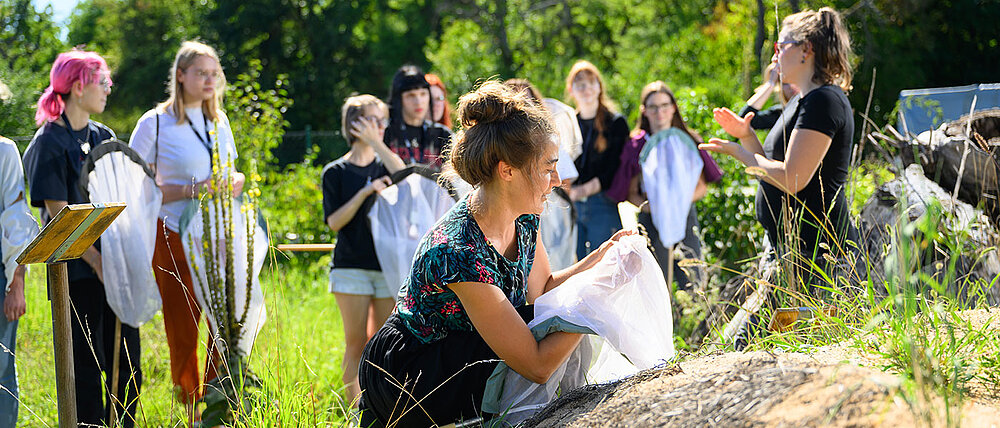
[701,7,858,286]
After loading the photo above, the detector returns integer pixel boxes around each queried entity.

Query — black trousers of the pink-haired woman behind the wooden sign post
[69,279,142,428]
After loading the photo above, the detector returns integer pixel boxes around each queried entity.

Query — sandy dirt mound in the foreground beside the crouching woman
[526,347,996,428]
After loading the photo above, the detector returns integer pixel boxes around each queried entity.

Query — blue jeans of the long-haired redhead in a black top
[573,192,622,260]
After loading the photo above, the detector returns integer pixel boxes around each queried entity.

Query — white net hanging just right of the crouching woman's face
[538,192,577,272]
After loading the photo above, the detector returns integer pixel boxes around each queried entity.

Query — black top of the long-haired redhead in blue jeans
[573,114,629,191]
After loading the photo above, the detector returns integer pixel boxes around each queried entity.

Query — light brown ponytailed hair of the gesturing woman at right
[781,7,854,92]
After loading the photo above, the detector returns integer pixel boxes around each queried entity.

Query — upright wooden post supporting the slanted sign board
[46,262,76,428]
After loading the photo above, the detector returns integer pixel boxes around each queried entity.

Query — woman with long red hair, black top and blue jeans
[566,60,629,260]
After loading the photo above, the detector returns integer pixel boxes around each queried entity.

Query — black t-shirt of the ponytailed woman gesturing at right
[756,85,858,259]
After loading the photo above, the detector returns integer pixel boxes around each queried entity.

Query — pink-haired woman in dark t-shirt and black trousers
[24,50,142,427]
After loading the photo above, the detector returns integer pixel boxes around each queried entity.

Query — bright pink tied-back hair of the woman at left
[35,50,111,125]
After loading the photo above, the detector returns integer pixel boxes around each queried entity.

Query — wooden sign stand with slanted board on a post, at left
[17,202,125,428]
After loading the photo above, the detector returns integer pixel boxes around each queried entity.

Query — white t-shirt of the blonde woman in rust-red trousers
[129,107,237,232]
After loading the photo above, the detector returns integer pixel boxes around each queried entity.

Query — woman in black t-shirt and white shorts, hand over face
[323,95,403,406]
